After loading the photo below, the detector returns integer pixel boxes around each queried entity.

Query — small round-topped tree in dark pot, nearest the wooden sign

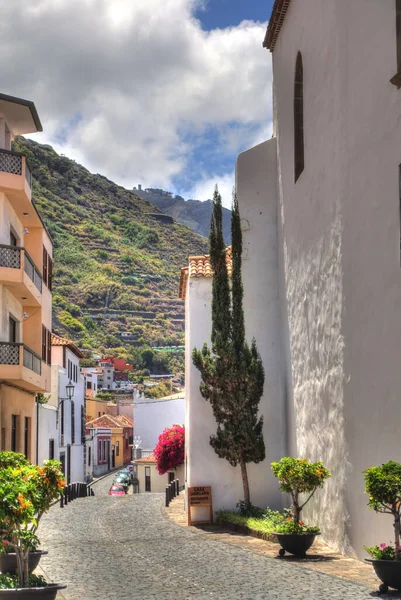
[271,456,330,557]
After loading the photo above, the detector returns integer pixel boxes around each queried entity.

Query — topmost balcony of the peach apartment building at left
[0,148,36,223]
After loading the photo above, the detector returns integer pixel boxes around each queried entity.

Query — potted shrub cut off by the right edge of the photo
[363,460,401,593]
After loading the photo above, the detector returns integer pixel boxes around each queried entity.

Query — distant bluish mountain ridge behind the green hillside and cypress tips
[134,188,231,245]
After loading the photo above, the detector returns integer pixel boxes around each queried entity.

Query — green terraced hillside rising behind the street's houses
[13,137,208,370]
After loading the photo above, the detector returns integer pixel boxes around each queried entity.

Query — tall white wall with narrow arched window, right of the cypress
[273,0,401,556]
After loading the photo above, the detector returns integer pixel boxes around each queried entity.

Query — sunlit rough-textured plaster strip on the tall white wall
[284,212,353,554]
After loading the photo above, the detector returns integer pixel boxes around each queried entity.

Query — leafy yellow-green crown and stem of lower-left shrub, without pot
[0,452,65,588]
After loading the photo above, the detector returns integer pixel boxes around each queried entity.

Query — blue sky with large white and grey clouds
[0,0,273,206]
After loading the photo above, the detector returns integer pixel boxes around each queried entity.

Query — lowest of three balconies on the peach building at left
[0,342,50,392]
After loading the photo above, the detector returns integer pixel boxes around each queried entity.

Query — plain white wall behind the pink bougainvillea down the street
[134,394,185,450]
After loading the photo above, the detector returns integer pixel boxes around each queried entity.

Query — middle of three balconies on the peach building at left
[0,244,42,306]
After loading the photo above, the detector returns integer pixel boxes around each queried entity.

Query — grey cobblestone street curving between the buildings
[39,478,371,600]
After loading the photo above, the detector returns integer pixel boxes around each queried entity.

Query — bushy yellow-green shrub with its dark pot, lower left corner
[0,452,65,600]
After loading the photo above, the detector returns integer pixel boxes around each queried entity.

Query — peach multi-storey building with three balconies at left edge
[0,94,52,460]
